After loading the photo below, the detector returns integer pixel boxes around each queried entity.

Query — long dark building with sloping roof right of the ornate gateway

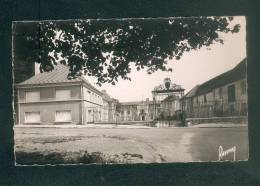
[181,59,247,118]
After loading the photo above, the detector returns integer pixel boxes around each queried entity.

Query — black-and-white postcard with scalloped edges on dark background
[13,16,248,165]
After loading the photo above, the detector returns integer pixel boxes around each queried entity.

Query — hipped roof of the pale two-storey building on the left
[17,64,102,94]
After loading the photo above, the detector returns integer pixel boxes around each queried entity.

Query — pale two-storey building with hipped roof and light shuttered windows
[16,65,115,124]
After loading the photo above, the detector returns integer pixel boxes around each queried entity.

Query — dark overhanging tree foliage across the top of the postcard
[13,17,240,85]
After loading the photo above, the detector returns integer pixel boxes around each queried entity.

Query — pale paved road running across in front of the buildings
[15,127,248,163]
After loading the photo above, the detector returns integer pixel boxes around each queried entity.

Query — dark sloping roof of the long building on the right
[184,58,246,97]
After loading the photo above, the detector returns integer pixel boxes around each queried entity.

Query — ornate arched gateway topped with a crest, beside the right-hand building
[152,78,185,119]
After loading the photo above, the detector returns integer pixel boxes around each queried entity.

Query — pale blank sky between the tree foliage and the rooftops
[90,17,246,101]
